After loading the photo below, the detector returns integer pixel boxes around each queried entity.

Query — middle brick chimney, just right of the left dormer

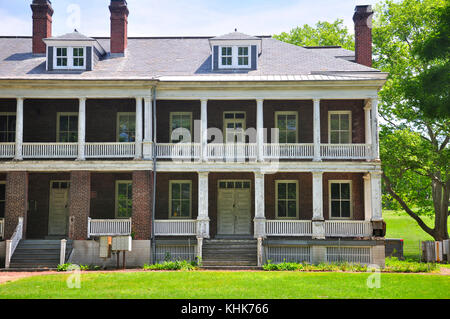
[109,0,129,56]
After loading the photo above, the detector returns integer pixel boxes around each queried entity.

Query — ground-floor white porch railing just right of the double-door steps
[266,220,312,236]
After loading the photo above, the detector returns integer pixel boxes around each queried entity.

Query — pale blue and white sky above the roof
[0,0,379,37]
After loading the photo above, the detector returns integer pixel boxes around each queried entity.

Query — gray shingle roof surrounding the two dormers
[0,37,382,81]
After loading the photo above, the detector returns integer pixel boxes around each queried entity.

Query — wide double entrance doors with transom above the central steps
[217,180,251,235]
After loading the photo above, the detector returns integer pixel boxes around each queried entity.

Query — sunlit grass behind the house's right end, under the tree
[383,210,450,259]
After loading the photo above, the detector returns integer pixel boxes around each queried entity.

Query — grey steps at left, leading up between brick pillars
[10,240,72,269]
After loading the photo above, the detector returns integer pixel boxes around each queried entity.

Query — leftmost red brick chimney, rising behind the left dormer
[31,0,53,54]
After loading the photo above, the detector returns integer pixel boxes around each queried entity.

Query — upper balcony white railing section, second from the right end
[264,144,314,159]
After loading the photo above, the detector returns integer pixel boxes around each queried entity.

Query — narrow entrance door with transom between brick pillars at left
[48,181,70,236]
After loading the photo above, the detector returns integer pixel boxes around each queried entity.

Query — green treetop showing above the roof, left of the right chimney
[274,19,355,50]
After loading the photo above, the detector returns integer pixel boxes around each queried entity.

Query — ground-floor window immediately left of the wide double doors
[169,181,192,219]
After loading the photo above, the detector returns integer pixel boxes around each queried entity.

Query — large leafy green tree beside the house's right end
[373,0,450,240]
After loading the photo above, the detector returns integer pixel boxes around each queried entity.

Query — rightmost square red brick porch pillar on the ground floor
[132,171,153,240]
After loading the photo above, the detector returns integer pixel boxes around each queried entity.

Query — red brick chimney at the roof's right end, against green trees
[353,5,373,67]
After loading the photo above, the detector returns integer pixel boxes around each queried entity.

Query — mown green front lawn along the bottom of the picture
[0,271,450,299]
